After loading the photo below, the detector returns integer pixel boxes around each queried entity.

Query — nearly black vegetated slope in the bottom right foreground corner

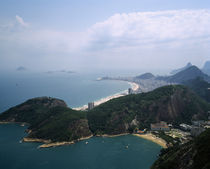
[151,129,210,169]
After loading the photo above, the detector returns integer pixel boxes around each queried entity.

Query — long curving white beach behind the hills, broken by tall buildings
[72,81,140,111]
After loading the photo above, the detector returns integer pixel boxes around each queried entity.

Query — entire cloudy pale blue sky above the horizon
[0,0,210,74]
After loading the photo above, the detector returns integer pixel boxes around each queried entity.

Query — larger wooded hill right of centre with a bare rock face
[87,85,209,134]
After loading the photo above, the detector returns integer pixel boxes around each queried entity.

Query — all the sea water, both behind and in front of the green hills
[0,73,161,169]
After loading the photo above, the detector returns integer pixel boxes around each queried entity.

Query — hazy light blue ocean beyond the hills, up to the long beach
[0,72,130,112]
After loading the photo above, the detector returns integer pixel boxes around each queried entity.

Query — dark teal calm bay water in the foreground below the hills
[0,124,161,169]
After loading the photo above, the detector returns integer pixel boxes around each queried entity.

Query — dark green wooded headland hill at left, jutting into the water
[0,97,91,142]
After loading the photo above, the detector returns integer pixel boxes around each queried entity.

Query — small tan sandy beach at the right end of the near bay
[133,133,167,148]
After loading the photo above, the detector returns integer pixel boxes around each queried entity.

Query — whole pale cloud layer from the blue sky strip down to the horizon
[0,9,210,70]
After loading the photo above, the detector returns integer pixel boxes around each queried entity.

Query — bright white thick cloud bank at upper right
[88,10,210,49]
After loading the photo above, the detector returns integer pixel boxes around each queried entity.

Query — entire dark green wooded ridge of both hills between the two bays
[0,85,210,142]
